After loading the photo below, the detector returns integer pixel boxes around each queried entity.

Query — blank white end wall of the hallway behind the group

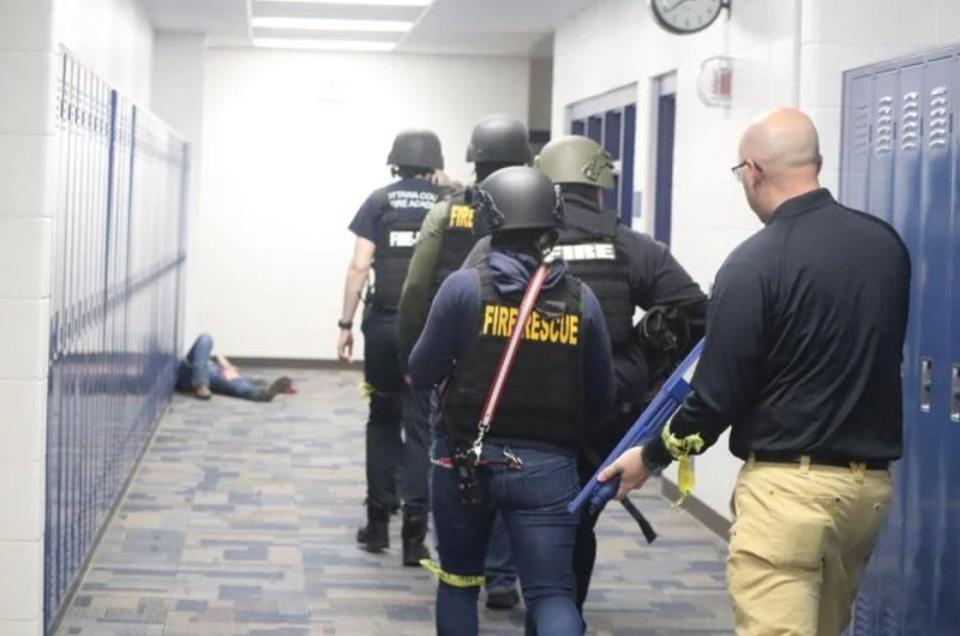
[198,49,530,359]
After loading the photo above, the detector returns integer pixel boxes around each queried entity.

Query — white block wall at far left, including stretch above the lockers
[0,0,153,636]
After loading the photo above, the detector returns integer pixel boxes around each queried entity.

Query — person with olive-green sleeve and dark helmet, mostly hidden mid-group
[398,115,533,609]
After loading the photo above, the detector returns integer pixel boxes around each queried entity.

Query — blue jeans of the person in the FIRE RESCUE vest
[430,438,583,636]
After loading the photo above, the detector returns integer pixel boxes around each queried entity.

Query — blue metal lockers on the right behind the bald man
[841,47,960,636]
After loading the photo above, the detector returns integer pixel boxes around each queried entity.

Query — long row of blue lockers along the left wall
[44,54,188,626]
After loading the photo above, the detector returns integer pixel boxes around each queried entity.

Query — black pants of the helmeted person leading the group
[362,308,430,518]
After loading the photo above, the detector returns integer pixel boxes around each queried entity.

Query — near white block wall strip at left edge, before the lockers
[0,0,57,635]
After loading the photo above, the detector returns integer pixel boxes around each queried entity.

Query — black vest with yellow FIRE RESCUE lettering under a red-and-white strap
[441,264,584,446]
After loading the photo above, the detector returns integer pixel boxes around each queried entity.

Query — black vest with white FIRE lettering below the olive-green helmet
[554,203,635,344]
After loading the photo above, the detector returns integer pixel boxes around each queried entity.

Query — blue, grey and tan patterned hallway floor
[57,370,732,636]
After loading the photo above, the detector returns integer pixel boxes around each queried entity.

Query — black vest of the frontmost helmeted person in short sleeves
[370,186,436,311]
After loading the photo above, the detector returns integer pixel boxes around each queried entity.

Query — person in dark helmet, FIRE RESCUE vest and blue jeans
[409,167,614,636]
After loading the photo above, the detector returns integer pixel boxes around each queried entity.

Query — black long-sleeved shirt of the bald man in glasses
[644,189,910,464]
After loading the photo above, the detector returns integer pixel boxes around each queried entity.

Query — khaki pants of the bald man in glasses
[727,460,891,636]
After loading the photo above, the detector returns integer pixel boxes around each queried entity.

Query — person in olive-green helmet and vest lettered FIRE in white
[466,135,707,611]
